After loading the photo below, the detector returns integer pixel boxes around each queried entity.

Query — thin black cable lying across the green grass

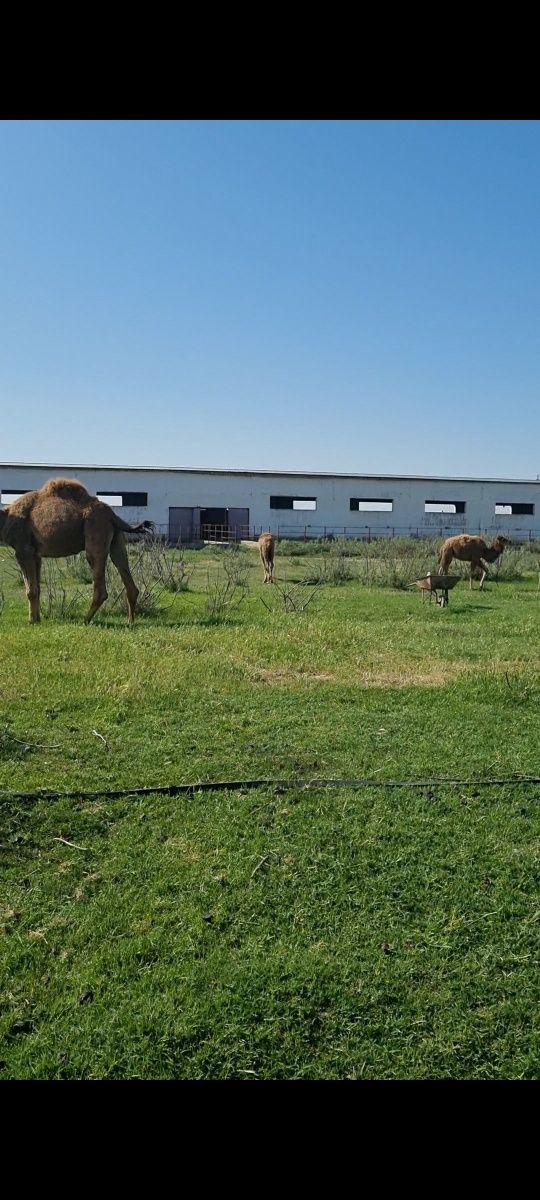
[0,775,540,800]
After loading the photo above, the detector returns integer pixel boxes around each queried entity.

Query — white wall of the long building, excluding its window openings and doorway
[0,464,540,536]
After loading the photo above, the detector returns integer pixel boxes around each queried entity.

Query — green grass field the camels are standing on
[0,545,540,1080]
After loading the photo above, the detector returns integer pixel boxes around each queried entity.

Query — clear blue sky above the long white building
[0,121,540,478]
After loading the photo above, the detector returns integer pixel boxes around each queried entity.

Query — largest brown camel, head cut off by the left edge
[0,479,154,625]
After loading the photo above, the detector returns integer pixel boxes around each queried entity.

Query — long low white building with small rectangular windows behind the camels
[0,463,540,542]
